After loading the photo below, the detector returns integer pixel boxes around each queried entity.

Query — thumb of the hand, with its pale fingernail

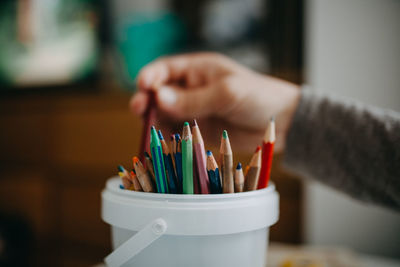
[157,86,217,119]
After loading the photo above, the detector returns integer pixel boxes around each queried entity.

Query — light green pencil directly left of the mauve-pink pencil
[182,122,194,194]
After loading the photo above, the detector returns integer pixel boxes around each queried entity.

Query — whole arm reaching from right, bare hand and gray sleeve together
[131,53,400,208]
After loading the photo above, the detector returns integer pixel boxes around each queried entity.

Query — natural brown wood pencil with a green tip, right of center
[219,130,235,193]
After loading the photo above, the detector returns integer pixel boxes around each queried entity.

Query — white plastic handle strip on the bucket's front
[104,218,167,267]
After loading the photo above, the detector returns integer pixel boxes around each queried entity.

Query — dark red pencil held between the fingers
[139,91,156,162]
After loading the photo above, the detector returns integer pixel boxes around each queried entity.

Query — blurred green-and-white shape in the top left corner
[0,0,99,87]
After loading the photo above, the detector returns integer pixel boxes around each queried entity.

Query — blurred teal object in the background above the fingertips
[115,12,186,88]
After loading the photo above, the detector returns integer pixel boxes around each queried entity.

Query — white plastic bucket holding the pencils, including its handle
[102,178,279,267]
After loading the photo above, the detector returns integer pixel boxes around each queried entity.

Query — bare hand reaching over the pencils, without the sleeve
[130,53,300,152]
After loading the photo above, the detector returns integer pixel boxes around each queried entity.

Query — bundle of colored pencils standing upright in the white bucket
[118,119,275,194]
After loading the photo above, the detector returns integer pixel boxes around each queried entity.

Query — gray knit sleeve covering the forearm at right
[284,90,400,209]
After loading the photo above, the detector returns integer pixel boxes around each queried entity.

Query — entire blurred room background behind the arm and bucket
[0,0,400,266]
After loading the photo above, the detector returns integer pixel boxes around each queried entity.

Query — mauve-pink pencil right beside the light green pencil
[192,120,210,194]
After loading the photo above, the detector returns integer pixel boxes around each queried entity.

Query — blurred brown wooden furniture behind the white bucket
[0,83,300,266]
